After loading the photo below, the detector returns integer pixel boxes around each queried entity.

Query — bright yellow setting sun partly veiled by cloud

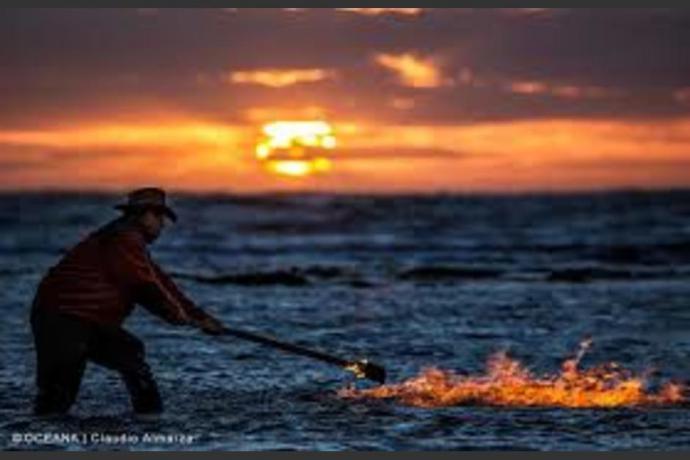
[256,121,336,177]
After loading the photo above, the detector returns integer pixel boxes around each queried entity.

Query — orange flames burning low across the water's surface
[340,341,685,408]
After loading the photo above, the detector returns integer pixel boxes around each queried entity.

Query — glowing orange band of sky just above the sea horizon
[0,119,690,193]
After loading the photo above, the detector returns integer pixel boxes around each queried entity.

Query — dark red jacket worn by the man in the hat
[34,219,206,325]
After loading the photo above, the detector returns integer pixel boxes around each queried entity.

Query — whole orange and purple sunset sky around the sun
[0,8,690,193]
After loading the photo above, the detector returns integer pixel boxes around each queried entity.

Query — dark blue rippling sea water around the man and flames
[0,191,690,450]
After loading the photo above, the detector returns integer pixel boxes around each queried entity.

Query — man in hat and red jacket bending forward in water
[31,187,223,415]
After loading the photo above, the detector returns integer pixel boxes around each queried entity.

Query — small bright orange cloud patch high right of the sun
[374,53,444,88]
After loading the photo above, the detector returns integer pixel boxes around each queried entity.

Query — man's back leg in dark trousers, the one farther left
[31,312,89,415]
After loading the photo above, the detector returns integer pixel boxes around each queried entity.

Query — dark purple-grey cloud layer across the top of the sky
[0,8,690,129]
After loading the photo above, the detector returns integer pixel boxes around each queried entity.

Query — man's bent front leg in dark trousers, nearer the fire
[89,327,163,413]
